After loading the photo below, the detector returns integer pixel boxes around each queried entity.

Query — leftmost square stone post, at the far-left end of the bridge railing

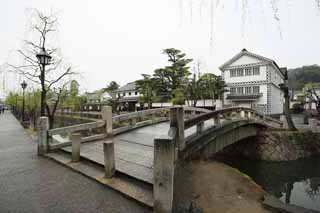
[38,117,49,155]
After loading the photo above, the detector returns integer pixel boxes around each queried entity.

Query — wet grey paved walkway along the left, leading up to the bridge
[0,112,150,213]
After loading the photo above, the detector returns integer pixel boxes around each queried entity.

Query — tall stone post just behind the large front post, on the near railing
[170,106,186,150]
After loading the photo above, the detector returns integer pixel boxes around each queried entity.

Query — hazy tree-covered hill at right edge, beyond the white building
[288,65,320,90]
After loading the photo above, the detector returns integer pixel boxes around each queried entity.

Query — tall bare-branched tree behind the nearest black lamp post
[8,9,75,121]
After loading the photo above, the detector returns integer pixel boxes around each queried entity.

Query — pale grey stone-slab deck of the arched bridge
[63,121,213,184]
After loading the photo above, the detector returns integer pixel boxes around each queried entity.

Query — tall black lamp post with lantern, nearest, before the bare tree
[36,47,52,116]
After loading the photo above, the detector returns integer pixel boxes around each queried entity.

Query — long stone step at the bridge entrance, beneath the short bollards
[45,150,154,208]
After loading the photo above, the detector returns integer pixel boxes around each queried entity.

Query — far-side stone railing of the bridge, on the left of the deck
[39,106,210,154]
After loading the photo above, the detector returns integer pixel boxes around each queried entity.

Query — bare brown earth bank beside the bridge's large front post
[177,161,270,213]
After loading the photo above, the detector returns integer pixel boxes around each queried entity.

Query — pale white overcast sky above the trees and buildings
[0,0,320,95]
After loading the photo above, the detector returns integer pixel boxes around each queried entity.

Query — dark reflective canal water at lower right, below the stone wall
[214,155,320,211]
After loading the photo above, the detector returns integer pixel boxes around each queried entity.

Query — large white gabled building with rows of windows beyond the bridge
[219,49,284,114]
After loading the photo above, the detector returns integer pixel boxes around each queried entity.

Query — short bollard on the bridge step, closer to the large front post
[103,140,116,178]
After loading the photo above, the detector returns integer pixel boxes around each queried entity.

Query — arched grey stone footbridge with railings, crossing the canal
[38,106,282,212]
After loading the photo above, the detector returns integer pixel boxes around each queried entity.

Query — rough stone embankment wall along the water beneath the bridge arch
[221,131,320,161]
